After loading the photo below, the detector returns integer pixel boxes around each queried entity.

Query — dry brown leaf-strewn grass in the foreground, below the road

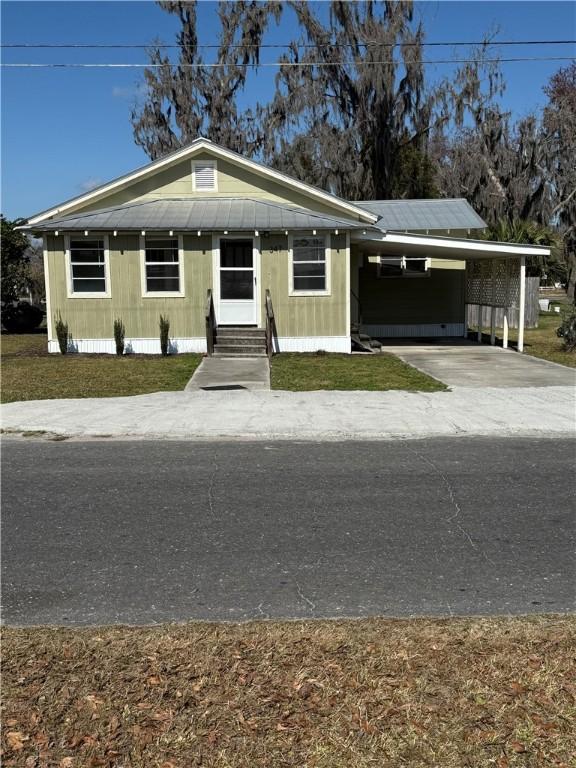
[2,616,576,768]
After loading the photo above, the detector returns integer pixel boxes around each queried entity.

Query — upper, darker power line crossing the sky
[0,40,576,49]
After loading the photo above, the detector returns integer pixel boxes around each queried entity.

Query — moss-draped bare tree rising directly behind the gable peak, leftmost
[131,0,281,160]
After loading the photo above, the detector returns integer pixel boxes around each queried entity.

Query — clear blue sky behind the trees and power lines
[1,0,576,218]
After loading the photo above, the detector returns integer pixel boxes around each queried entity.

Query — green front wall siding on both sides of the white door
[47,235,348,339]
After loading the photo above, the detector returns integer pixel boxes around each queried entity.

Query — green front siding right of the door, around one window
[260,235,350,337]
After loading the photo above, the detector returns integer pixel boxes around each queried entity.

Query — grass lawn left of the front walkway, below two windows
[1,333,202,403]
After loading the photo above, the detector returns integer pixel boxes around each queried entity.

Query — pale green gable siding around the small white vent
[71,152,355,218]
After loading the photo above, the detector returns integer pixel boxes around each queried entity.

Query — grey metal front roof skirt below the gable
[26,197,378,232]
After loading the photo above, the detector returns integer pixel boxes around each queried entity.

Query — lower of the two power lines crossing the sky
[0,56,574,69]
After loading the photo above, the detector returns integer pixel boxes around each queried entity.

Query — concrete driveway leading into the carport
[382,339,576,388]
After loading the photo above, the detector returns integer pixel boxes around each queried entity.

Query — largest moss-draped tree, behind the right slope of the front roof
[260,0,499,199]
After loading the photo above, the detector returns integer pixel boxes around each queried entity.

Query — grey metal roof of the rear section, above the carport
[355,198,487,231]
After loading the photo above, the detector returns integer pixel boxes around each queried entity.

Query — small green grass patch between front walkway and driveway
[271,352,446,392]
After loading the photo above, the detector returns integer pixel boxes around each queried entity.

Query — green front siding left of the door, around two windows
[47,235,212,339]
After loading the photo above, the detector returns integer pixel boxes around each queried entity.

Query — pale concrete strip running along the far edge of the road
[1,387,575,440]
